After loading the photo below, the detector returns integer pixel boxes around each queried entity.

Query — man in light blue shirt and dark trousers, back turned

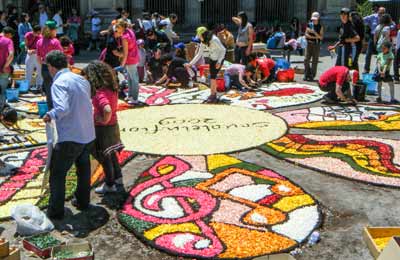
[43,51,95,219]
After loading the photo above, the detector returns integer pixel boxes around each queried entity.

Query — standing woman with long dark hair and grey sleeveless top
[232,11,254,65]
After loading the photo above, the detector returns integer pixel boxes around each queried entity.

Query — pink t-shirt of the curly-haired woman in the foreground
[92,88,118,126]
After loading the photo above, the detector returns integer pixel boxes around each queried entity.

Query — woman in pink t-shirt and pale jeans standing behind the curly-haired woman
[115,19,140,105]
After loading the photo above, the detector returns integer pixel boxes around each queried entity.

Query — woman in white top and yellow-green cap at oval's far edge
[186,27,226,103]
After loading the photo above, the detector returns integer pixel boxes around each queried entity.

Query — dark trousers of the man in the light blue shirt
[48,142,92,215]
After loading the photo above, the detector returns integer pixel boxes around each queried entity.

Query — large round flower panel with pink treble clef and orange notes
[118,155,321,259]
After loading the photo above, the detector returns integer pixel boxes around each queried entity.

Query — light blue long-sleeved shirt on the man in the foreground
[48,69,96,144]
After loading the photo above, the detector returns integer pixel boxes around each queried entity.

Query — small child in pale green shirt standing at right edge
[374,41,399,104]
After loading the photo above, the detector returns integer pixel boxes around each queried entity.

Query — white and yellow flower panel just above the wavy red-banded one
[276,105,400,131]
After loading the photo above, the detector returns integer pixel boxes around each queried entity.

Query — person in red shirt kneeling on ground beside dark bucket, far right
[319,66,359,104]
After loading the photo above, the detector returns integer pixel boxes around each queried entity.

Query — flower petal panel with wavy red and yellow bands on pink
[261,134,400,187]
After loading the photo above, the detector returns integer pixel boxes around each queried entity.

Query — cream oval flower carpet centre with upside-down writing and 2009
[118,104,287,155]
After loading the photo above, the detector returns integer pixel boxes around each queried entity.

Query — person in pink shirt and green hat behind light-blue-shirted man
[36,21,63,110]
